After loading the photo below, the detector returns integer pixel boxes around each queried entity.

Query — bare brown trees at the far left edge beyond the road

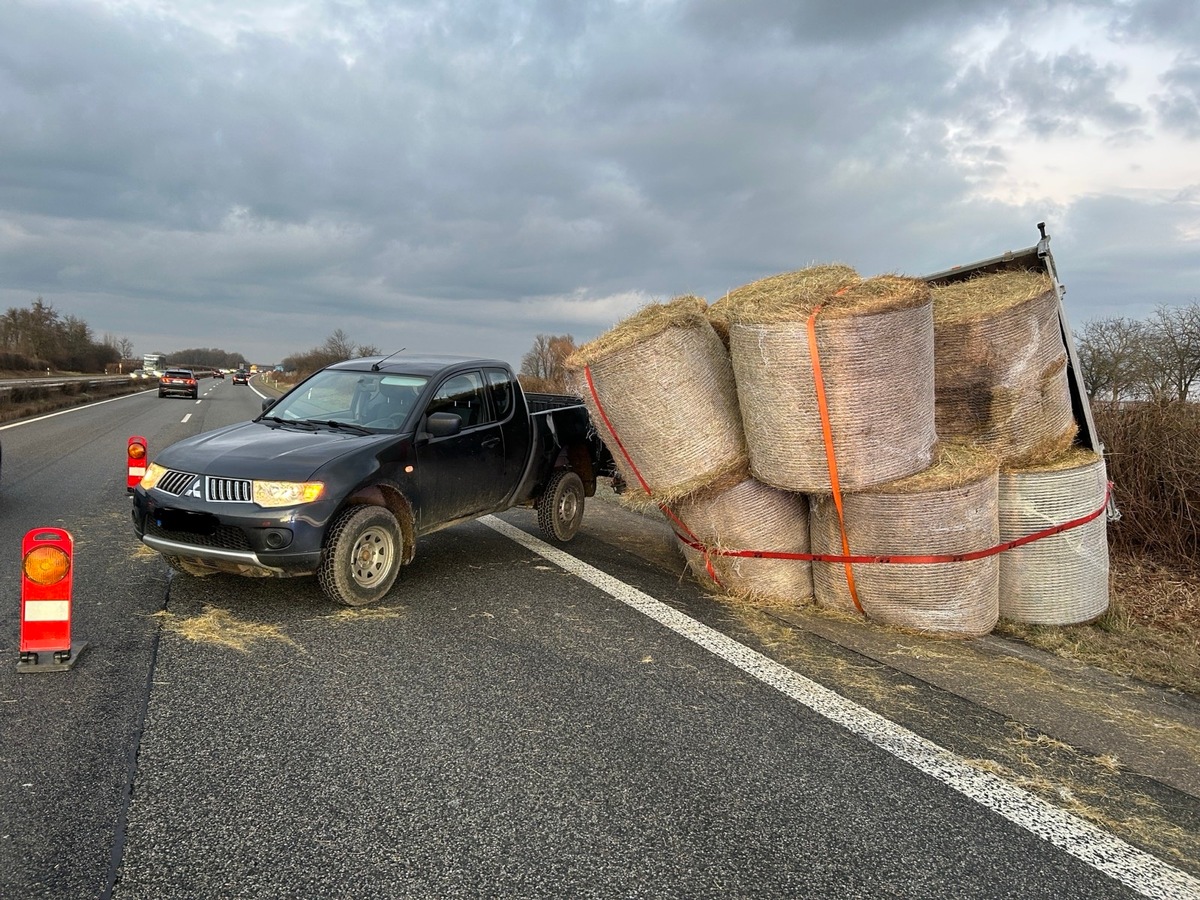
[0,298,125,372]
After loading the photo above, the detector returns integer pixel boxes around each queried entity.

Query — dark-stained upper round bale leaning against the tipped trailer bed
[934,271,1076,464]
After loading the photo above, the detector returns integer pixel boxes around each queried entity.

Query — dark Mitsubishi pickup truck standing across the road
[133,354,613,606]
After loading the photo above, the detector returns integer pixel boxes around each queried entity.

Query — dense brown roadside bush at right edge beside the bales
[1092,402,1200,574]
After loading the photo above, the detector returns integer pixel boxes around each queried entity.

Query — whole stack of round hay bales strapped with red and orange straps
[568,265,1108,637]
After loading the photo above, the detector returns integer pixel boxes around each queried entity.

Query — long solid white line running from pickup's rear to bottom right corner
[480,516,1200,900]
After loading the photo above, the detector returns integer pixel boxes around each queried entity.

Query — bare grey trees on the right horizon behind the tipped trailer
[1075,301,1200,403]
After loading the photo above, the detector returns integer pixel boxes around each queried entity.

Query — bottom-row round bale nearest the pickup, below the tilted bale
[672,478,812,604]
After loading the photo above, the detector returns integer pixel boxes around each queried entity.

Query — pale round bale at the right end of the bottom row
[1000,448,1109,625]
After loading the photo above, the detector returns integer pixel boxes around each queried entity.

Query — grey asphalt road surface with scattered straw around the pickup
[0,380,1200,900]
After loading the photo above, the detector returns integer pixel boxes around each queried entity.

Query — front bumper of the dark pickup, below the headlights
[132,487,334,577]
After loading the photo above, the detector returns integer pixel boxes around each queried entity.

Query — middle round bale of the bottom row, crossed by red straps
[810,445,1000,637]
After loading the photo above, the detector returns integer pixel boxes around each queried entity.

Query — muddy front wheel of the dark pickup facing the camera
[317,506,404,606]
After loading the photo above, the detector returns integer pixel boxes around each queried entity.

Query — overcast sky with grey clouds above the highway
[0,0,1200,365]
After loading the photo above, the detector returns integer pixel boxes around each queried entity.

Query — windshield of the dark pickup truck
[263,368,428,431]
